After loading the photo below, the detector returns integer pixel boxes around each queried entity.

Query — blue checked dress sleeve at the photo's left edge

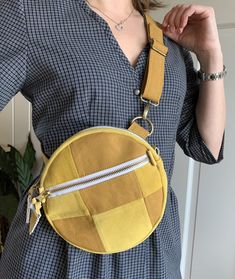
[0,0,27,111]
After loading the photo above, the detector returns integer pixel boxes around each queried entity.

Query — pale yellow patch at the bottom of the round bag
[93,199,152,251]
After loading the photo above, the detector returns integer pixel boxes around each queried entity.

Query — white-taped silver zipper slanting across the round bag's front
[48,154,149,198]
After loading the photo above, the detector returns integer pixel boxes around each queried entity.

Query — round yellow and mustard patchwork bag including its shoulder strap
[27,14,167,254]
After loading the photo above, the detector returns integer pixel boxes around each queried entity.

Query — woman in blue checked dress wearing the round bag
[0,0,225,279]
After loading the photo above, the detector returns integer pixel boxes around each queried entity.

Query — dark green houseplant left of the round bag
[0,135,36,253]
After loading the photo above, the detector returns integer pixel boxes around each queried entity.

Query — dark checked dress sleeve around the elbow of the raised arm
[176,49,225,164]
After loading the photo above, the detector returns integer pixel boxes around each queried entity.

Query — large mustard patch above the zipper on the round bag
[71,132,146,175]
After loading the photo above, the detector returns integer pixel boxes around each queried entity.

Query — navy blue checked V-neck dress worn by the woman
[0,0,223,279]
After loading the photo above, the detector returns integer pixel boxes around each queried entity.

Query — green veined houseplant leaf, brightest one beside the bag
[10,146,33,198]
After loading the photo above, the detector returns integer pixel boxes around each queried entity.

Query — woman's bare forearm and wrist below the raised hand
[196,51,226,159]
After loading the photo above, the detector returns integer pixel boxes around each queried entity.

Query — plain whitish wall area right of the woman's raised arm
[191,28,235,279]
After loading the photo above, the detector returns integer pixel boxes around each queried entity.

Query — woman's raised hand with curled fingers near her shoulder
[162,4,222,70]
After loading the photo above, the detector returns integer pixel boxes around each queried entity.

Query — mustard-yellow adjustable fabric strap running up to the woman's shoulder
[141,14,168,104]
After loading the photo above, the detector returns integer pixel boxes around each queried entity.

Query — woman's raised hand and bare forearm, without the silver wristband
[163,4,225,159]
